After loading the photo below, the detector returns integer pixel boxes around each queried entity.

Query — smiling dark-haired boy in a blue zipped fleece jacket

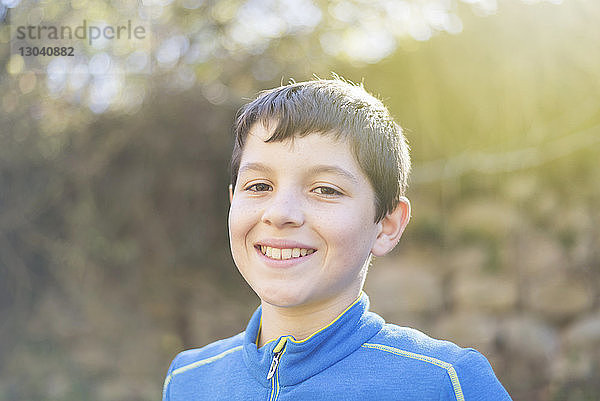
[163,79,510,401]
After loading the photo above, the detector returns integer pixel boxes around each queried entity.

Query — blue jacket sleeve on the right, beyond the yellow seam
[440,349,512,401]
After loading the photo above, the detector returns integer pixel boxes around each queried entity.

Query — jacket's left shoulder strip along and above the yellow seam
[170,332,244,371]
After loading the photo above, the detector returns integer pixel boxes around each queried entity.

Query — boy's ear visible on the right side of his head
[371,196,410,256]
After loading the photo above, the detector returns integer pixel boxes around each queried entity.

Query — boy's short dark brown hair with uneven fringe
[231,79,410,222]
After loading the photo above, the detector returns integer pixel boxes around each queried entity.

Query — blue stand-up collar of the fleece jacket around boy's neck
[243,292,384,387]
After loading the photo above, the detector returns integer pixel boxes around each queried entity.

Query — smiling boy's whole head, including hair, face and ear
[229,80,410,307]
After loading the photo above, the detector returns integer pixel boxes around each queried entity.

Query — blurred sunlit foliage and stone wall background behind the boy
[0,0,600,401]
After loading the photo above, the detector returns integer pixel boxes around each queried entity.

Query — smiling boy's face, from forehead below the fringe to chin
[229,123,381,307]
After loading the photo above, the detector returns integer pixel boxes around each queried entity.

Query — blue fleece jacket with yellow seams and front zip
[163,293,511,401]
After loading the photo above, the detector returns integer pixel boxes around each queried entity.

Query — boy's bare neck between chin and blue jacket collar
[257,290,362,348]
